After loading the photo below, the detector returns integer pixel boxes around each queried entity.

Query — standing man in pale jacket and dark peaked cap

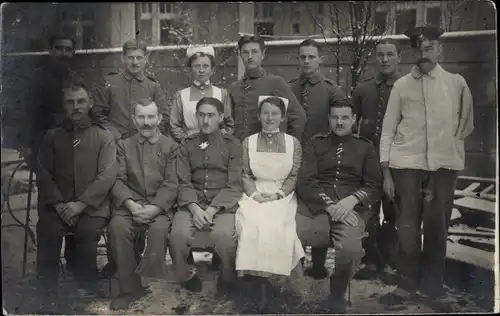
[380,27,474,305]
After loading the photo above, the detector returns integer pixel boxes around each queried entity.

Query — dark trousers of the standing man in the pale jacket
[391,169,458,289]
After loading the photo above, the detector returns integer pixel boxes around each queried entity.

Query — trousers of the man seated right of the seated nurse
[295,213,366,299]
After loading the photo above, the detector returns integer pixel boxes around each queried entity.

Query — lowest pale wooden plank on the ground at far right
[446,242,495,271]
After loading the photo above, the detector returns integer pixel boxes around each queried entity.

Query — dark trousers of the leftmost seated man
[37,210,108,288]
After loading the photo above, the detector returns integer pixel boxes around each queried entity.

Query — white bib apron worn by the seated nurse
[235,134,304,276]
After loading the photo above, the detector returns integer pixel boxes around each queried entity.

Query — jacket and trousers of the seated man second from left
[108,133,177,293]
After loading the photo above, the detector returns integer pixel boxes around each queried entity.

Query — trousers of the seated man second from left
[108,212,171,294]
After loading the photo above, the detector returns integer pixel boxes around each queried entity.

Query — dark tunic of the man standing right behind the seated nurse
[229,68,306,141]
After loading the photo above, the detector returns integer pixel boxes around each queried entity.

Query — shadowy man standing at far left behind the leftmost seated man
[27,32,81,271]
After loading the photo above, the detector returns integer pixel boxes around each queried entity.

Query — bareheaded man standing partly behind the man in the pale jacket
[353,39,401,279]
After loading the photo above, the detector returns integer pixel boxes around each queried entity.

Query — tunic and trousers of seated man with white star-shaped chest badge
[170,131,243,281]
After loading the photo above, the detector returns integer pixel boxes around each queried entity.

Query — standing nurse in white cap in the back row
[170,46,234,143]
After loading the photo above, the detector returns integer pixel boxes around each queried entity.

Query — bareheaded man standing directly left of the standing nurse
[95,40,170,139]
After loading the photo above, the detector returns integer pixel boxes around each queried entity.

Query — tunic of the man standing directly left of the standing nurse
[94,71,170,139]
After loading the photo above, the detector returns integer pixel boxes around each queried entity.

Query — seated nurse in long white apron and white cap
[235,96,304,278]
